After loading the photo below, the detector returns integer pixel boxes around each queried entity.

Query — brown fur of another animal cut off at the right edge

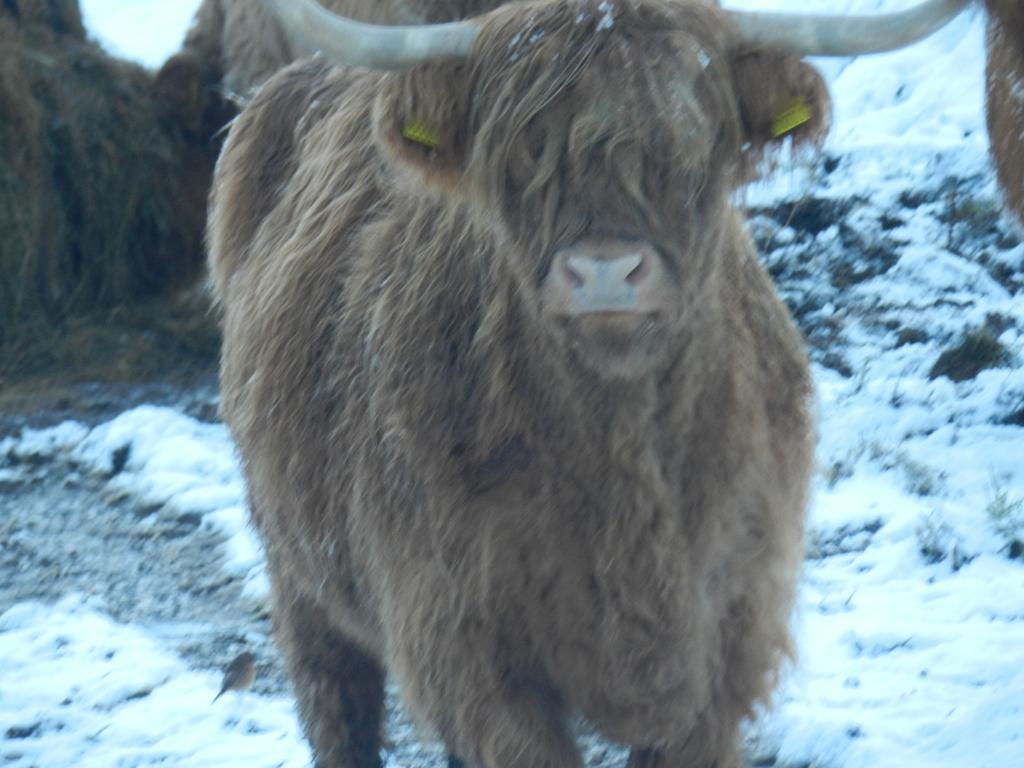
[985,0,1024,220]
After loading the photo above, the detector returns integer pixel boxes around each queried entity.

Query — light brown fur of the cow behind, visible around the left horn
[174,0,520,97]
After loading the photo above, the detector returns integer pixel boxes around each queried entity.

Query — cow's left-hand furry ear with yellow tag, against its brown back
[374,63,469,186]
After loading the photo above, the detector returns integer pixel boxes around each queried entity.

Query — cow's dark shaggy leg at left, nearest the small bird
[274,592,384,768]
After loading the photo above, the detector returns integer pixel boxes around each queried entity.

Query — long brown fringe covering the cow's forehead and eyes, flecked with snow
[458,0,741,234]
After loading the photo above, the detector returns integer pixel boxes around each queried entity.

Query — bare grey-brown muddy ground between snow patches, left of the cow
[0,385,286,692]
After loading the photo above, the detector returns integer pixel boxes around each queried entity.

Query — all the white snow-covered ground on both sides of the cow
[0,0,1024,768]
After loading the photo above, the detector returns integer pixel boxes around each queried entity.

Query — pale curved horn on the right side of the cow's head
[726,0,971,56]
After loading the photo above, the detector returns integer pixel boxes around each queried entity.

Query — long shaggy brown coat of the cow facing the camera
[209,0,828,768]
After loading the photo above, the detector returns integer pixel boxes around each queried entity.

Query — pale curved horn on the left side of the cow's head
[263,0,477,70]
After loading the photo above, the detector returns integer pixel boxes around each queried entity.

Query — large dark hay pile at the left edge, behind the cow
[0,0,226,375]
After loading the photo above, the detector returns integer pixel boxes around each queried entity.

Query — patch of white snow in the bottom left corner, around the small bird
[0,595,309,768]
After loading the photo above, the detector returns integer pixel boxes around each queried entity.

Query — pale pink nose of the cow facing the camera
[544,238,665,315]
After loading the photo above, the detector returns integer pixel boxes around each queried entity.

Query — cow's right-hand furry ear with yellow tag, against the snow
[732,48,831,159]
